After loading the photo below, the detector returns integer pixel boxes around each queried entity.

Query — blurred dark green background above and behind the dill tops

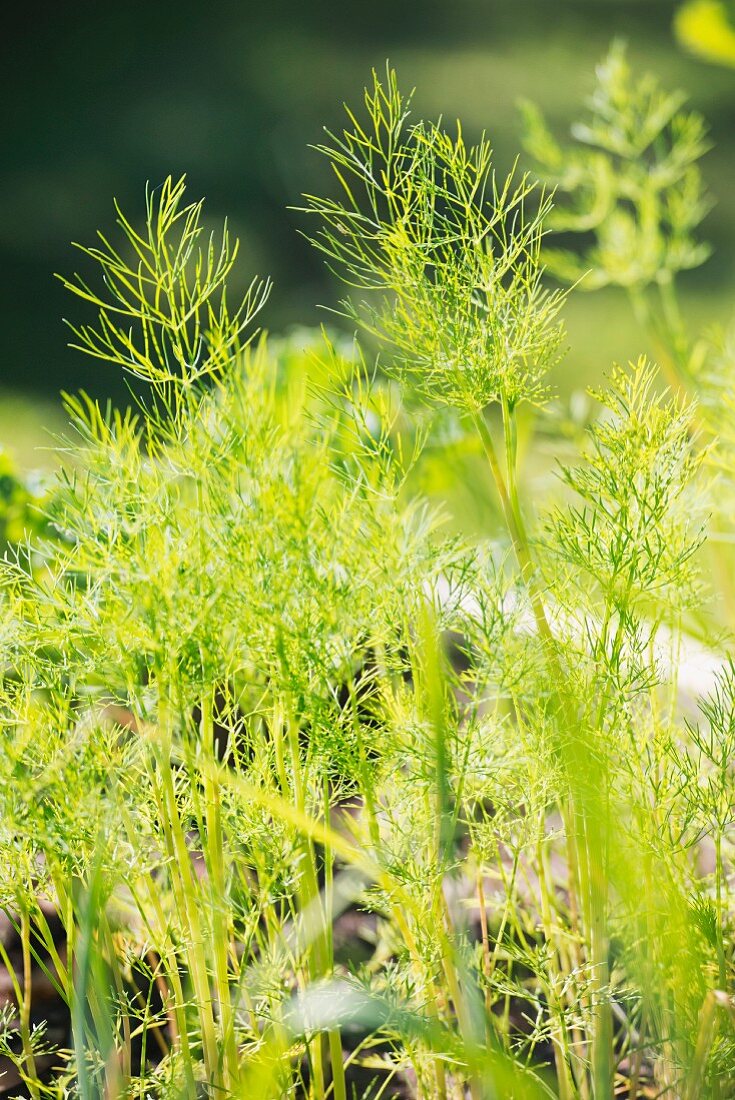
[0,0,735,465]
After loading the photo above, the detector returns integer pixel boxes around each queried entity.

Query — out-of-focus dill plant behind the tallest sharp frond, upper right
[522,42,734,629]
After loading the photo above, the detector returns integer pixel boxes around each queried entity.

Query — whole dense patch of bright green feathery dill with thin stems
[0,46,735,1100]
